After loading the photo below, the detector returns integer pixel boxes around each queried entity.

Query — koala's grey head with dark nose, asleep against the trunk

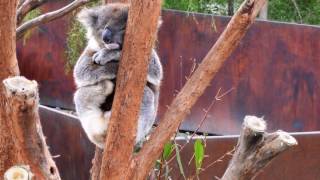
[78,3,129,49]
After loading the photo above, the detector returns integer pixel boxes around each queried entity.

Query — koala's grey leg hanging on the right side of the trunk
[136,86,158,145]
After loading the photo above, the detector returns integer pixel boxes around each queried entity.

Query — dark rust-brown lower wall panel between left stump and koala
[40,107,94,180]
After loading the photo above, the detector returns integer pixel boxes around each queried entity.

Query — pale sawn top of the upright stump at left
[3,76,38,102]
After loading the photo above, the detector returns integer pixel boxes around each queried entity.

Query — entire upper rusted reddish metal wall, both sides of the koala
[18,2,320,134]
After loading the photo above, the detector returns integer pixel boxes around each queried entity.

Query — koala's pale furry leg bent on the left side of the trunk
[74,80,114,148]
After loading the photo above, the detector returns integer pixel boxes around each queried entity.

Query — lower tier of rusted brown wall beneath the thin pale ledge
[40,107,320,180]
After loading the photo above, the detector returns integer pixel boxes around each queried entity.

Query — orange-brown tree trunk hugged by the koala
[100,0,161,180]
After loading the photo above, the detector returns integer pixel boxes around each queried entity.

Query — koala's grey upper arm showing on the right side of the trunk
[147,49,163,87]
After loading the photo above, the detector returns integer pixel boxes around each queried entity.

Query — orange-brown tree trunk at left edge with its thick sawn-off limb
[0,0,60,179]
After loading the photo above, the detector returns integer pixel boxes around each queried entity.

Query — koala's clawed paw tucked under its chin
[92,49,121,65]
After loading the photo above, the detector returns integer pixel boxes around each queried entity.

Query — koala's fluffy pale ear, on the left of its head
[77,8,98,28]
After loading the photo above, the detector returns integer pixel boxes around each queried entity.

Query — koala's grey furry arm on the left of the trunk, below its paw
[73,47,118,87]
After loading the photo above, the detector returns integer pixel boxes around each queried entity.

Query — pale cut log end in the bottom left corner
[4,165,33,180]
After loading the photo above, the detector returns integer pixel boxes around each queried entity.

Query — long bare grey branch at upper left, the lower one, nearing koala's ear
[16,0,90,39]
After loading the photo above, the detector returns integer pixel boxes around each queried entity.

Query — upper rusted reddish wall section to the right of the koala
[159,11,320,134]
